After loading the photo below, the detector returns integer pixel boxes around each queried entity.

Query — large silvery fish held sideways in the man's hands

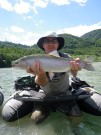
[12,54,95,72]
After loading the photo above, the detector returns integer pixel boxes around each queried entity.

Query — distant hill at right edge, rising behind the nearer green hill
[81,29,101,44]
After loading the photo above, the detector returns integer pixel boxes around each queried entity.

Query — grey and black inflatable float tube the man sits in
[2,76,101,122]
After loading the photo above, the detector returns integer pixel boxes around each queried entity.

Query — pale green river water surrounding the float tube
[0,62,101,135]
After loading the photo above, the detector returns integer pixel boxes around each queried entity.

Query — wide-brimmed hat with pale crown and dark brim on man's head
[37,32,64,50]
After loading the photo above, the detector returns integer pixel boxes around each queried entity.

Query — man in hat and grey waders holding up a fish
[27,33,80,123]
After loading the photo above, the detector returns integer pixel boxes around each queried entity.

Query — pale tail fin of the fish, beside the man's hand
[83,58,95,71]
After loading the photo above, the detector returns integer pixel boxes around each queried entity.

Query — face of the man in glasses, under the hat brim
[43,37,59,53]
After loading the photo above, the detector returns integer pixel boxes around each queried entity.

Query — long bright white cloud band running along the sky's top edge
[0,0,87,14]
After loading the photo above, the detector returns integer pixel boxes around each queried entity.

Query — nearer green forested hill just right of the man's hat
[61,34,101,56]
